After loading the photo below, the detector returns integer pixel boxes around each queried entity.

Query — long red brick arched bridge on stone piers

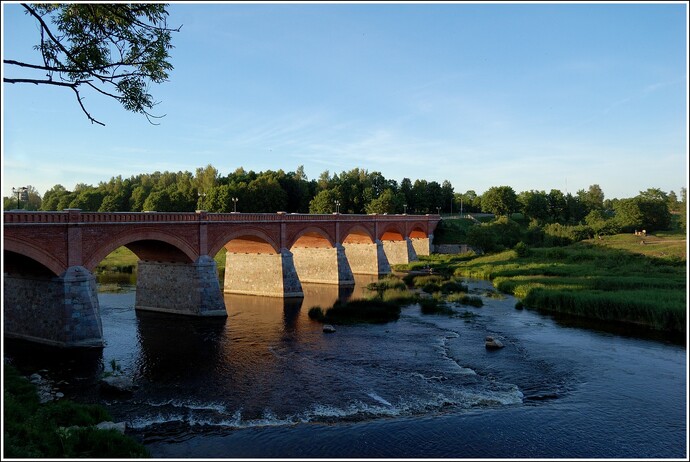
[3,209,440,347]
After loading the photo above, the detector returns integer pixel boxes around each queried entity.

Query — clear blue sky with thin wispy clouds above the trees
[2,2,688,198]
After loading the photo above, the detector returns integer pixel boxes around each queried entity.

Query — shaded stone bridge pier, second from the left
[135,255,228,316]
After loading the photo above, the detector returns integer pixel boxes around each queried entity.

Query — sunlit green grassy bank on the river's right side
[454,234,687,333]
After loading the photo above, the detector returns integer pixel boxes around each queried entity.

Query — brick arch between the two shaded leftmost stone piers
[84,228,199,271]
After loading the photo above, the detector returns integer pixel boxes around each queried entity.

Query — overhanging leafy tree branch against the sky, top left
[3,3,180,125]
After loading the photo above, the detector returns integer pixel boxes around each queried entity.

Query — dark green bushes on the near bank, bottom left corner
[3,364,150,459]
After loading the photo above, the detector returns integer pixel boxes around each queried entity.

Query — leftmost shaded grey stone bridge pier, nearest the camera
[3,266,103,348]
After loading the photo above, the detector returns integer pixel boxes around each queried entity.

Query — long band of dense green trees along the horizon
[3,165,687,234]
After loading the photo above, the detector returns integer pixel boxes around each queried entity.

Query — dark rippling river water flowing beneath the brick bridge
[5,278,688,459]
